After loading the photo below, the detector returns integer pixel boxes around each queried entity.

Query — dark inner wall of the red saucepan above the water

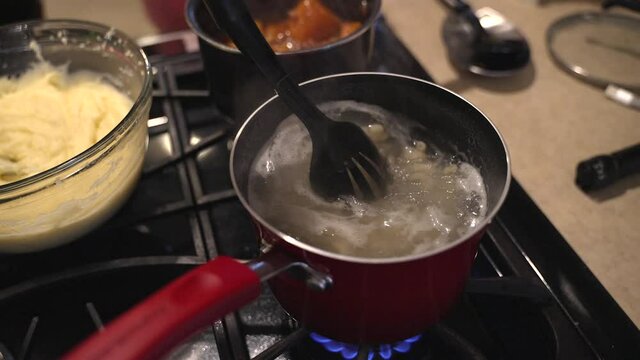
[231,73,510,218]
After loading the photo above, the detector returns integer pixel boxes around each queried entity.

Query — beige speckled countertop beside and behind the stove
[43,0,640,326]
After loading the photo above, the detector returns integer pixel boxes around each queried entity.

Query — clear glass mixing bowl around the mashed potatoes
[0,20,152,253]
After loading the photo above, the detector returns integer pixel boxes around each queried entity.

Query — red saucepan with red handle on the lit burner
[67,73,510,360]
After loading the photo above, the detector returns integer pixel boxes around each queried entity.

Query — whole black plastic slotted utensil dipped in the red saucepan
[204,0,388,201]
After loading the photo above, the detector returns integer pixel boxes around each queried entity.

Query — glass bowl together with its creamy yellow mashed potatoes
[0,20,152,253]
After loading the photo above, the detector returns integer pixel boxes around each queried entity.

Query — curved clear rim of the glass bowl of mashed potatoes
[0,19,153,194]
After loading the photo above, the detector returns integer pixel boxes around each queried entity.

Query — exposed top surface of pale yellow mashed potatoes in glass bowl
[0,62,133,185]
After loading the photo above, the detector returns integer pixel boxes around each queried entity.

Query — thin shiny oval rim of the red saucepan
[229,72,511,264]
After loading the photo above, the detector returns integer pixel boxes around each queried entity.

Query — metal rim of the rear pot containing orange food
[184,0,382,56]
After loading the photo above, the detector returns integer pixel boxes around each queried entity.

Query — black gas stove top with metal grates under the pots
[0,19,640,360]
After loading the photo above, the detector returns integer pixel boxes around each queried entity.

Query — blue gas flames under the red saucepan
[309,333,422,360]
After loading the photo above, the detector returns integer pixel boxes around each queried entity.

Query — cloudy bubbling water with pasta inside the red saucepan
[248,101,486,258]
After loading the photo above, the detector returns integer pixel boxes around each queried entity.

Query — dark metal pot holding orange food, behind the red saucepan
[186,0,381,121]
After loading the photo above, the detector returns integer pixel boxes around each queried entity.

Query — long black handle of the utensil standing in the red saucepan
[203,0,326,137]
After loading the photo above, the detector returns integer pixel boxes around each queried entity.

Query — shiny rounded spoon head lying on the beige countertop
[441,0,531,77]
